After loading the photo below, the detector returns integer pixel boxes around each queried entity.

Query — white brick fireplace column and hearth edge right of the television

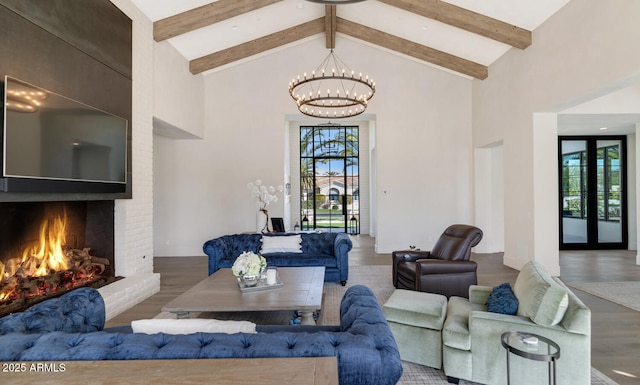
[99,0,160,319]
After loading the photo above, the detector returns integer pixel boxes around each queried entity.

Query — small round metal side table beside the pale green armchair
[501,332,560,385]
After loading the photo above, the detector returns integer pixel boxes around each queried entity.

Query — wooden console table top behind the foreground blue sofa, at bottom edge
[1,357,338,385]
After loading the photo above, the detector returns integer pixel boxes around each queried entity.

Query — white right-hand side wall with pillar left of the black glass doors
[473,0,640,275]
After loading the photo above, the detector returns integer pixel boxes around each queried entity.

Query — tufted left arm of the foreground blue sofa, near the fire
[0,287,105,335]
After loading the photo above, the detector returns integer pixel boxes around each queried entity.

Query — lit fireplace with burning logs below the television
[0,201,117,316]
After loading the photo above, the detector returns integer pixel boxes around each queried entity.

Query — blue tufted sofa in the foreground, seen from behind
[0,286,402,385]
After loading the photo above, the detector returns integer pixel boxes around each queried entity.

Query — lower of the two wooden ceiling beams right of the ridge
[336,17,488,80]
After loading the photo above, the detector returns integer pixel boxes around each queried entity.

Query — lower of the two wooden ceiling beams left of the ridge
[189,17,325,75]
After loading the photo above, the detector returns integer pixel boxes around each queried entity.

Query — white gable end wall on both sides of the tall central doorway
[154,34,473,256]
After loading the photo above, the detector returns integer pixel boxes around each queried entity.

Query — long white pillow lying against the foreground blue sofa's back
[131,318,256,334]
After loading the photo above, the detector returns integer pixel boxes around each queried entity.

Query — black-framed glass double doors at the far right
[558,136,628,250]
